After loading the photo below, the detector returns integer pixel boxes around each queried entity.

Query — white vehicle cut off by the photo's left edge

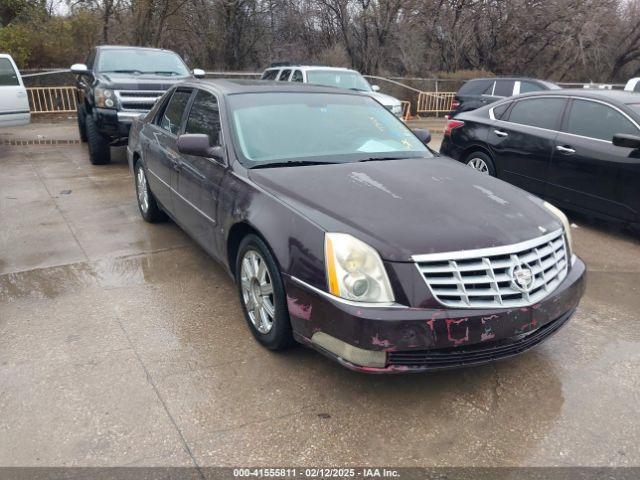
[0,53,31,127]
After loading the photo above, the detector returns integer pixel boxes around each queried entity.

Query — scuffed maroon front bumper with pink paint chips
[284,258,586,373]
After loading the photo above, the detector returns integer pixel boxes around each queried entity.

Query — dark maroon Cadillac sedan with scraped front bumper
[128,80,585,372]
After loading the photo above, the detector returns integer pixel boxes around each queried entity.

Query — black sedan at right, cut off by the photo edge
[440,90,640,231]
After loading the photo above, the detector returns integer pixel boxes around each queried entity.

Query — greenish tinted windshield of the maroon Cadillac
[229,93,433,166]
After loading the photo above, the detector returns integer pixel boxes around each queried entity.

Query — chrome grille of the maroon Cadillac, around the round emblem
[413,229,568,308]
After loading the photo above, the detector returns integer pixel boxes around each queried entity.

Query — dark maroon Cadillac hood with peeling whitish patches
[249,157,561,261]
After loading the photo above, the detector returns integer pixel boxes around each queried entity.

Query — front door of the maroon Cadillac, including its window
[175,90,226,251]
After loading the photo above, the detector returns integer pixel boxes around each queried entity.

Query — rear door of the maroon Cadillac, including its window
[146,88,191,213]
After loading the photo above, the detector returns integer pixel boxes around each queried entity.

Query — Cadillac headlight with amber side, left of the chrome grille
[324,233,395,303]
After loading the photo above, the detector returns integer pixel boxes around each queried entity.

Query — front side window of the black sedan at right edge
[565,100,639,142]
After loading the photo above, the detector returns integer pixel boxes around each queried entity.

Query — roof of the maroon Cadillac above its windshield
[180,78,366,96]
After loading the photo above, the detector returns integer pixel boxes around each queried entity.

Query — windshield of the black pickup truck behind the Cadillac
[98,48,189,77]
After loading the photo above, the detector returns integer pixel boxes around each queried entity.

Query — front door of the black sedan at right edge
[548,98,640,221]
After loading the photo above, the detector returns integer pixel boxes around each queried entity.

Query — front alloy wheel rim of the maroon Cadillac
[240,250,276,335]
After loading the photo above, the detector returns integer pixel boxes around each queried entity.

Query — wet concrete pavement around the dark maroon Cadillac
[0,122,640,466]
